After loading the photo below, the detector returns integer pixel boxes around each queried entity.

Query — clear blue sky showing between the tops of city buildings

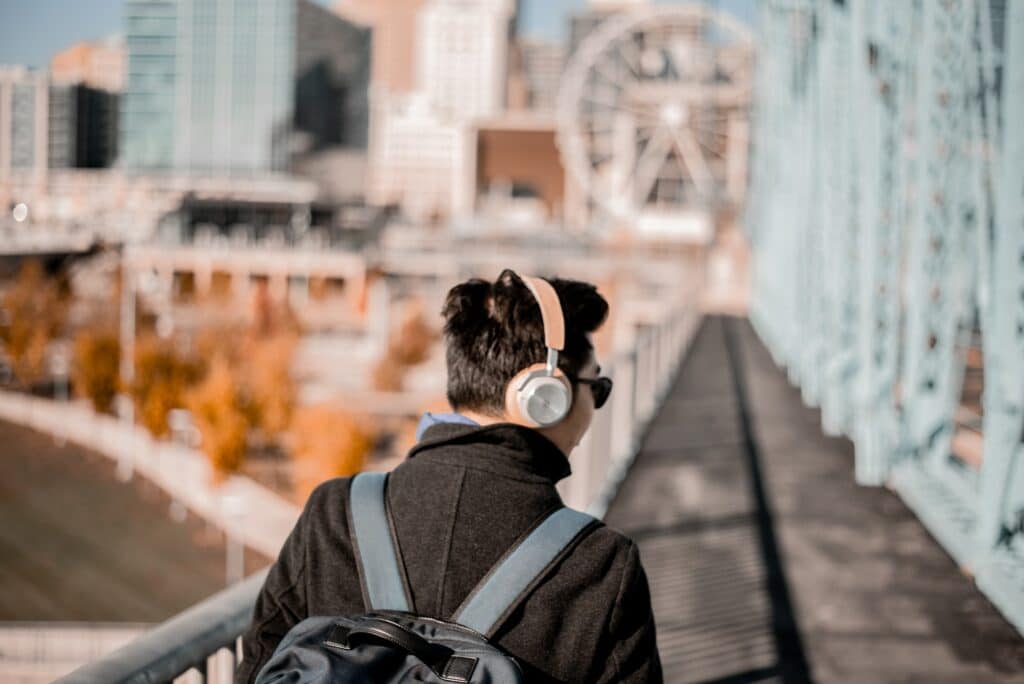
[0,0,756,67]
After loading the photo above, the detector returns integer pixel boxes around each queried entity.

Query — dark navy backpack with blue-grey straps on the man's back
[250,473,596,684]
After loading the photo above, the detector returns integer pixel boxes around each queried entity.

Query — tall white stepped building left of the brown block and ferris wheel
[370,0,514,220]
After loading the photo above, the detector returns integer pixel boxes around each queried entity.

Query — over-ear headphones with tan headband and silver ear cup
[505,275,572,427]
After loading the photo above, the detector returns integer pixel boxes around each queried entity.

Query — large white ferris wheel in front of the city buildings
[557,4,754,232]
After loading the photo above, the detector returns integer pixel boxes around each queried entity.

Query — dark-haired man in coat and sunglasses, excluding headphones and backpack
[237,270,662,682]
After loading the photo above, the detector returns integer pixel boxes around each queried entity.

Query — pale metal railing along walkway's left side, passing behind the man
[58,297,700,684]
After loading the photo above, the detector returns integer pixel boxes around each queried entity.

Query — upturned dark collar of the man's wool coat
[409,422,572,484]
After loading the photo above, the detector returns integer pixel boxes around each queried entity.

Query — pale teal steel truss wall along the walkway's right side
[745,0,1024,632]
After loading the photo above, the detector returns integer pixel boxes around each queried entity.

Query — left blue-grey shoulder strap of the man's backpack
[348,473,412,610]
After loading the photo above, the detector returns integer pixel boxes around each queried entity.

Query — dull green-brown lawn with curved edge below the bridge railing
[0,413,268,622]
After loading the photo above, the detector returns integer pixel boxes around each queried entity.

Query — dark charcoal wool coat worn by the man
[236,423,662,683]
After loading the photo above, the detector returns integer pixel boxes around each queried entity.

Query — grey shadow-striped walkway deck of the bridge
[606,317,1024,684]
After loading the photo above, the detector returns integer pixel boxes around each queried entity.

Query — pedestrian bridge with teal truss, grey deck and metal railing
[54,0,1024,682]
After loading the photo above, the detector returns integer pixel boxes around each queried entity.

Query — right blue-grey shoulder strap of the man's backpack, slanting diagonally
[452,508,597,637]
